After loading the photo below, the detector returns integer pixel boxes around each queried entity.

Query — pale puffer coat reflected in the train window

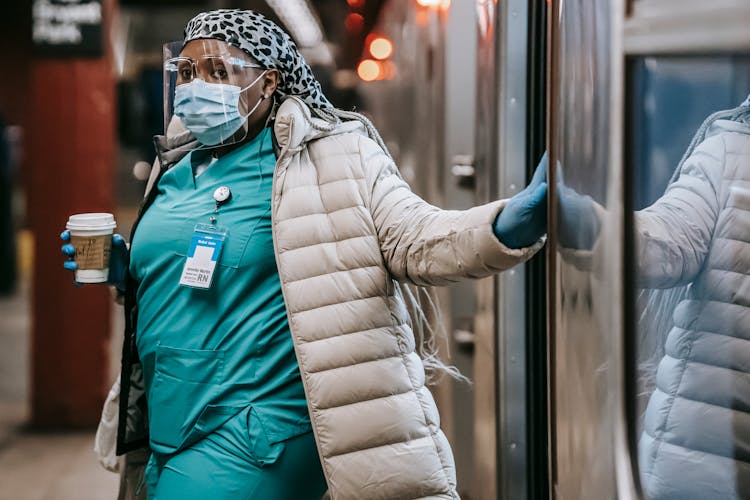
[635,116,750,500]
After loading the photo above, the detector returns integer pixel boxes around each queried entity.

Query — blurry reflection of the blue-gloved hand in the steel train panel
[557,172,601,250]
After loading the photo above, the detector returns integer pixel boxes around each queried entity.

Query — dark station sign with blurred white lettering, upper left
[32,0,103,58]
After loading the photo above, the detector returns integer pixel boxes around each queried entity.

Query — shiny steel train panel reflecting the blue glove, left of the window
[549,0,627,500]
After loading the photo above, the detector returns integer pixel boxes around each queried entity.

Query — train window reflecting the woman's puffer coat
[627,55,750,500]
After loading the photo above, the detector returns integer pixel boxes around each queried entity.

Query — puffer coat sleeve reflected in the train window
[635,135,726,288]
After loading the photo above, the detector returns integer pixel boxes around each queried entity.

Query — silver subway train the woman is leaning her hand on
[360,0,750,500]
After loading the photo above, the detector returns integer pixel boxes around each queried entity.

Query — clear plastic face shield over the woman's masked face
[164,40,266,148]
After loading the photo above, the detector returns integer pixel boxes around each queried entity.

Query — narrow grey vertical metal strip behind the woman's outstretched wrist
[496,0,529,498]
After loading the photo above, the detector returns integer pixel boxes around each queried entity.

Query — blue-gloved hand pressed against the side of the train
[492,153,547,248]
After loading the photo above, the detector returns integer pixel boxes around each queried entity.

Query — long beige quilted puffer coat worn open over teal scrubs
[118,97,544,500]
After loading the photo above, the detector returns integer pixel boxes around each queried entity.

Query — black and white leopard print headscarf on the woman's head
[183,9,339,123]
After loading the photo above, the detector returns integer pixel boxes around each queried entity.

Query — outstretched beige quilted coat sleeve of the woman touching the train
[360,137,544,285]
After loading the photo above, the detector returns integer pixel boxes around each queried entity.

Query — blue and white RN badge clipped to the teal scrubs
[180,224,228,289]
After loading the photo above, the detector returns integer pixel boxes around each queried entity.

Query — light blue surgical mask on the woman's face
[174,71,266,146]
